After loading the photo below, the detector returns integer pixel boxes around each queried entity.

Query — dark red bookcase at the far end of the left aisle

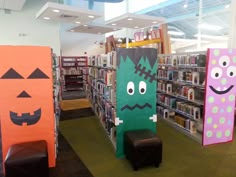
[61,56,87,91]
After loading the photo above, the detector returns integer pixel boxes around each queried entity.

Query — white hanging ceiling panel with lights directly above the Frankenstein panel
[105,13,165,28]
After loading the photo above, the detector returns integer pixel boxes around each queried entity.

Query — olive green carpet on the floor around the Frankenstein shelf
[60,117,236,177]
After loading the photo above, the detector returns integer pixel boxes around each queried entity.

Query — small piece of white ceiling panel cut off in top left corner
[0,0,26,10]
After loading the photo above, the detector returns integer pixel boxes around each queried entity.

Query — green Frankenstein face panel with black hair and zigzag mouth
[115,48,157,158]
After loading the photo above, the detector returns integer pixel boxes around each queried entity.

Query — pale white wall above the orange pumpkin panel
[0,0,60,55]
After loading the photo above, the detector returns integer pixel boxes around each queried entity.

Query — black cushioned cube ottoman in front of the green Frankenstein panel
[124,129,162,170]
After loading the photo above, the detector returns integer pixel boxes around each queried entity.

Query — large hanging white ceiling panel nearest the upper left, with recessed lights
[36,2,102,25]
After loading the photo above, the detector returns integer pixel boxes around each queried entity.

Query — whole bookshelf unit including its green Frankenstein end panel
[87,48,157,158]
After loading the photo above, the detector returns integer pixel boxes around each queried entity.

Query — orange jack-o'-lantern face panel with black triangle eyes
[0,46,55,167]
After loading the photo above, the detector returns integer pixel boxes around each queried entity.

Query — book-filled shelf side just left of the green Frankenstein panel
[86,51,116,148]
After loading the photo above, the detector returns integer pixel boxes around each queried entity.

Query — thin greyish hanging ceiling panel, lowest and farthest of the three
[68,24,119,34]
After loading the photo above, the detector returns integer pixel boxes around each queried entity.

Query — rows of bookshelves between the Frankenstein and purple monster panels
[157,52,206,142]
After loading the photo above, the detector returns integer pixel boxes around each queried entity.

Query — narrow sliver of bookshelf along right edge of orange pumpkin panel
[52,53,61,155]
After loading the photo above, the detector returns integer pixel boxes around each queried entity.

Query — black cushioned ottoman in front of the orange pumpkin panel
[5,141,49,177]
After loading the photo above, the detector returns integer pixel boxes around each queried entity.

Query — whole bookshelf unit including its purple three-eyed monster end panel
[157,48,236,146]
